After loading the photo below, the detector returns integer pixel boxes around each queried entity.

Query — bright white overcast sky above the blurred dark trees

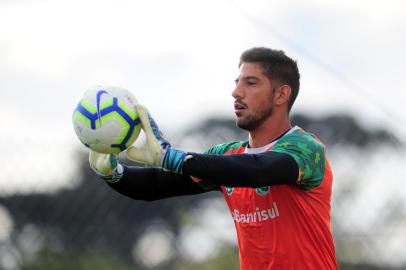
[0,0,406,194]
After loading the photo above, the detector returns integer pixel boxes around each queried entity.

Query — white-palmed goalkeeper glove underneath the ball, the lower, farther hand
[89,150,124,183]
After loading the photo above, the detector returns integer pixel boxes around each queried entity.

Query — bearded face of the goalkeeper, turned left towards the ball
[232,63,273,131]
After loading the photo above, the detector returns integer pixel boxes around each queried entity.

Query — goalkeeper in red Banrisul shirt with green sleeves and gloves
[89,48,338,270]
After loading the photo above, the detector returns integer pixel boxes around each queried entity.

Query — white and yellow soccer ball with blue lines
[72,85,141,154]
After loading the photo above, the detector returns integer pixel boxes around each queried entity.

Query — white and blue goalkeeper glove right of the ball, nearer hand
[127,105,187,174]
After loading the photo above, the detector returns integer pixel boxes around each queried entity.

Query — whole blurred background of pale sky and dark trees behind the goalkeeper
[0,0,406,270]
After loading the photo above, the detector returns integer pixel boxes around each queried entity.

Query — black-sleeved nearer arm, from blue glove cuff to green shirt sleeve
[182,152,299,188]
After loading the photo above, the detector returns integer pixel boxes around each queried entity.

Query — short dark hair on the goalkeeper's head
[238,47,300,111]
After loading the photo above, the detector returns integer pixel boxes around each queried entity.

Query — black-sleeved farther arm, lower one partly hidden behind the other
[109,166,208,201]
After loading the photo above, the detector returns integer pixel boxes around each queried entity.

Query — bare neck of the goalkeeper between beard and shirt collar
[248,114,292,148]
